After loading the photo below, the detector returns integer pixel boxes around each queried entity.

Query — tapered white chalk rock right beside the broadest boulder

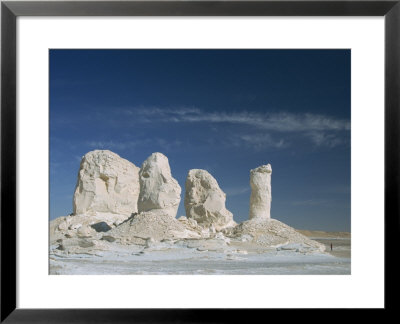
[138,153,181,218]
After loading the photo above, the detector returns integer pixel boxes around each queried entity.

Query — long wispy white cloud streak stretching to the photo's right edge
[114,106,350,150]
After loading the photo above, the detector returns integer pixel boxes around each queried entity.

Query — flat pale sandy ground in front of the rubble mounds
[49,233,351,275]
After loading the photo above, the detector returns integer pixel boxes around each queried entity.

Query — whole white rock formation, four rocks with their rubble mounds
[50,150,327,266]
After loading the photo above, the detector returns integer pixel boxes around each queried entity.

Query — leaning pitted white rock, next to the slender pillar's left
[185,169,236,231]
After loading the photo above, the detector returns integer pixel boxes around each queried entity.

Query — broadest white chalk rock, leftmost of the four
[73,150,139,216]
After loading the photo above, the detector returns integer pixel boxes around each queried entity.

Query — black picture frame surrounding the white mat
[0,0,400,323]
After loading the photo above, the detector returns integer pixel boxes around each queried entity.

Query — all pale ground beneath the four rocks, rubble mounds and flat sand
[49,213,351,275]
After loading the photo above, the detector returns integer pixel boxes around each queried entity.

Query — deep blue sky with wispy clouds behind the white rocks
[50,50,351,231]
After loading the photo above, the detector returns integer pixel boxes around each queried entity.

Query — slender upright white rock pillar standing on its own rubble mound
[249,164,272,220]
